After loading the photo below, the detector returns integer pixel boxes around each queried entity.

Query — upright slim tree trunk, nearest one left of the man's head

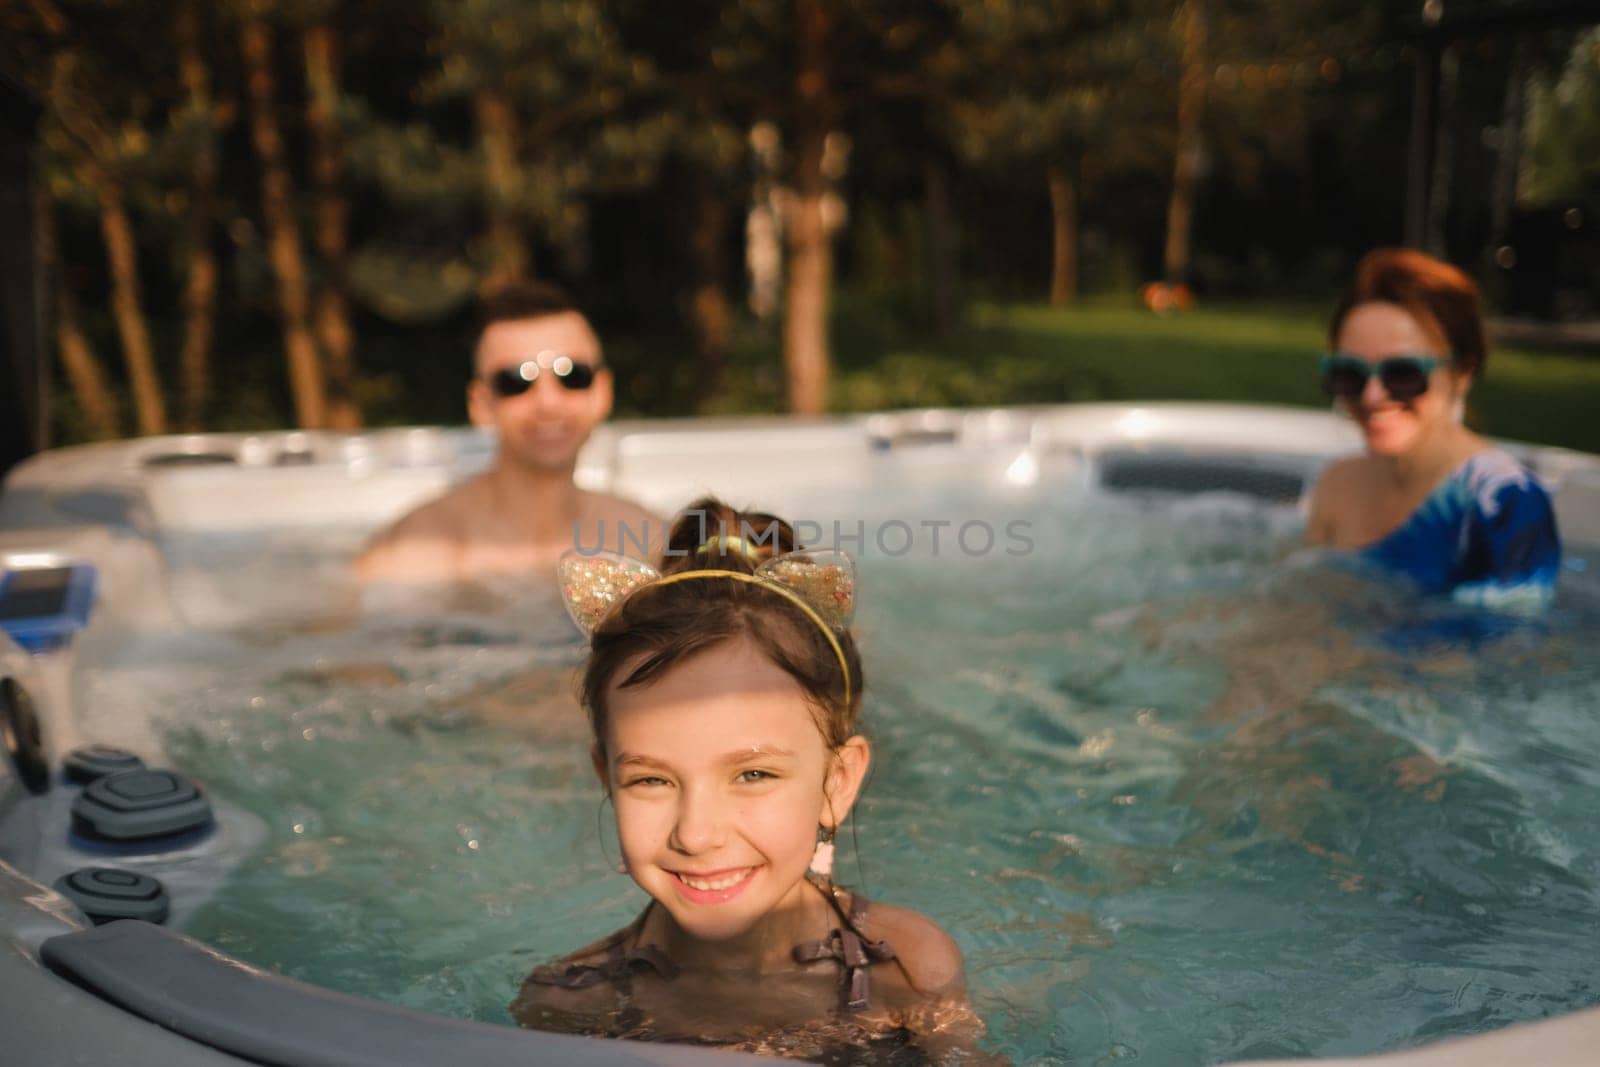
[306,24,362,430]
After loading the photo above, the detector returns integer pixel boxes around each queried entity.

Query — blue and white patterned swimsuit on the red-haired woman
[1362,448,1562,606]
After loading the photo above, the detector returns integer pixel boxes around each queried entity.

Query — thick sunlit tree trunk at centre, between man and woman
[784,0,834,414]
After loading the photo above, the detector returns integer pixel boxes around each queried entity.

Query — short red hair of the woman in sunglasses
[1328,248,1488,378]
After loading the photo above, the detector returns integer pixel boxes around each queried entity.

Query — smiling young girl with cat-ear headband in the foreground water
[512,501,981,1062]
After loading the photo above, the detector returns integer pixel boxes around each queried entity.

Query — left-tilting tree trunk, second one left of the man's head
[240,18,328,429]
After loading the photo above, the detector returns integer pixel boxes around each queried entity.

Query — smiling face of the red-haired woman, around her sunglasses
[1334,301,1472,456]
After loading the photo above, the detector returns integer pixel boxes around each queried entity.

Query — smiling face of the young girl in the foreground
[595,641,870,941]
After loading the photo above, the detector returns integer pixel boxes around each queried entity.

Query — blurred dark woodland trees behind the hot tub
[0,0,1600,440]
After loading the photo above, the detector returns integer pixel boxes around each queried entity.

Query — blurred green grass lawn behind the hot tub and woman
[790,296,1600,453]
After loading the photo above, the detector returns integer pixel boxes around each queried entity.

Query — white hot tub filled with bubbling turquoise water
[0,405,1600,1064]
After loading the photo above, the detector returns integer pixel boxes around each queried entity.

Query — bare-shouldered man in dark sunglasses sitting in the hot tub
[355,282,666,581]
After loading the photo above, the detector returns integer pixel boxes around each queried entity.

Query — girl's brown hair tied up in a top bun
[579,498,862,767]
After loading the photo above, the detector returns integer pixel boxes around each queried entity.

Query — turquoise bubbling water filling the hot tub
[131,494,1600,1064]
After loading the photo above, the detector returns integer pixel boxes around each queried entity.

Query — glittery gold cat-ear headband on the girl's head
[555,542,856,705]
